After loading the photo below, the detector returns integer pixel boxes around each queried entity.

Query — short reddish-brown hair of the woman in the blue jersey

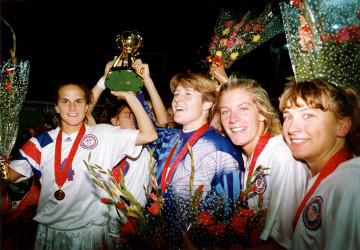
[170,71,217,123]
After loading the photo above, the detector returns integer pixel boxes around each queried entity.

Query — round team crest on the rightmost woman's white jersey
[303,196,322,230]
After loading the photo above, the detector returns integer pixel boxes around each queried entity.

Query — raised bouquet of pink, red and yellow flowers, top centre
[207,4,283,68]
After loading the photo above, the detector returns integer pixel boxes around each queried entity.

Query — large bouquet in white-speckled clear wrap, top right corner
[280,0,360,91]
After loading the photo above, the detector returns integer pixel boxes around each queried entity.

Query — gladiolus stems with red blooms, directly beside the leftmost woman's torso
[84,150,169,249]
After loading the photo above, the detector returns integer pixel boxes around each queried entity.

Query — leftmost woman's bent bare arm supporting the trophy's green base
[110,91,158,145]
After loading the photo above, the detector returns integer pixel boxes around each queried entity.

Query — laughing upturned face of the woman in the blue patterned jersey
[172,85,212,131]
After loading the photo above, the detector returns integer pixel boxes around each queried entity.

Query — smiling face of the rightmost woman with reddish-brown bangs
[283,98,340,167]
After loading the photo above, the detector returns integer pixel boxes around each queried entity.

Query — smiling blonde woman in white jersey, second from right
[215,72,308,249]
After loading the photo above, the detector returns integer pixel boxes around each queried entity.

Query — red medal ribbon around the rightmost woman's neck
[293,148,351,231]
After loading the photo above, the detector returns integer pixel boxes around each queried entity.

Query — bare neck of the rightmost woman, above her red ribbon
[306,141,345,177]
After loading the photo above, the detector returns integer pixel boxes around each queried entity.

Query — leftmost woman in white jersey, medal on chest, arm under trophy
[5,79,157,249]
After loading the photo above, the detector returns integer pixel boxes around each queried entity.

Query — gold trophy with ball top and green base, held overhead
[105,30,143,93]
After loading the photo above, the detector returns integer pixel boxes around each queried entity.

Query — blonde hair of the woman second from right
[219,72,282,137]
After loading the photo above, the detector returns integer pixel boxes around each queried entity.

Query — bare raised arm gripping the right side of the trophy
[133,59,168,127]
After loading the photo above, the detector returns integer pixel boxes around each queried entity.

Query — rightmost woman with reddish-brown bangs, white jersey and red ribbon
[280,79,360,249]
